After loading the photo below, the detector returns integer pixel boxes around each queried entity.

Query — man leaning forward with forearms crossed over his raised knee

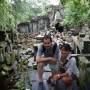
[36,35,60,90]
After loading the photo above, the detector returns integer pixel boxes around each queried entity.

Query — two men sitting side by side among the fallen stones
[36,35,79,90]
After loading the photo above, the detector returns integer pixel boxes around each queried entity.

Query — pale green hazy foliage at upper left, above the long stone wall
[0,0,49,31]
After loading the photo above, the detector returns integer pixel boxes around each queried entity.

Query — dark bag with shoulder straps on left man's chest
[42,43,57,57]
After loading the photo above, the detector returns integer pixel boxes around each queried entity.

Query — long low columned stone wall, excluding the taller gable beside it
[18,16,49,33]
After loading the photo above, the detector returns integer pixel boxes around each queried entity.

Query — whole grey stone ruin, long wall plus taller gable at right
[17,5,64,33]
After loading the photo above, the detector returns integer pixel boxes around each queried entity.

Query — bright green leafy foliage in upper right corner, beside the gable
[61,0,90,27]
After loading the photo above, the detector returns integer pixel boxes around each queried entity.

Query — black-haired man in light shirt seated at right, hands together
[53,44,79,90]
